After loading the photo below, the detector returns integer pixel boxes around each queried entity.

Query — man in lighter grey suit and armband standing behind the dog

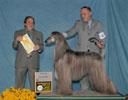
[63,6,105,90]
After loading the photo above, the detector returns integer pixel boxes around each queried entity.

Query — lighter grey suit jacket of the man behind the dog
[66,19,105,53]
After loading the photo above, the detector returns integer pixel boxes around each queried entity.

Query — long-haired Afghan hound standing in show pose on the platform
[45,32,117,95]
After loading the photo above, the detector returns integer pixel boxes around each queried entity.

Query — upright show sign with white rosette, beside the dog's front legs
[35,72,53,93]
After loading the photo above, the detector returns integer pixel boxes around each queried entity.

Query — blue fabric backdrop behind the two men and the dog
[0,0,128,95]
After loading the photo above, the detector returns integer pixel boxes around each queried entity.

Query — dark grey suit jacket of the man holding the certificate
[13,29,44,68]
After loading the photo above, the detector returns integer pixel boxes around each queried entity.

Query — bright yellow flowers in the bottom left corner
[0,87,36,100]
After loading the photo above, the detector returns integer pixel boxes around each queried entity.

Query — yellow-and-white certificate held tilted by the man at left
[20,34,35,54]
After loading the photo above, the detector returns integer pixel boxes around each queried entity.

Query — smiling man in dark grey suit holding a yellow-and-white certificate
[13,16,44,91]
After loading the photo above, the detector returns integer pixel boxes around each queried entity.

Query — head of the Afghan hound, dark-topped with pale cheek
[45,31,64,44]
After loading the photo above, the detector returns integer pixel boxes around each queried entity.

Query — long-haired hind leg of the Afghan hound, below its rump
[89,59,117,94]
